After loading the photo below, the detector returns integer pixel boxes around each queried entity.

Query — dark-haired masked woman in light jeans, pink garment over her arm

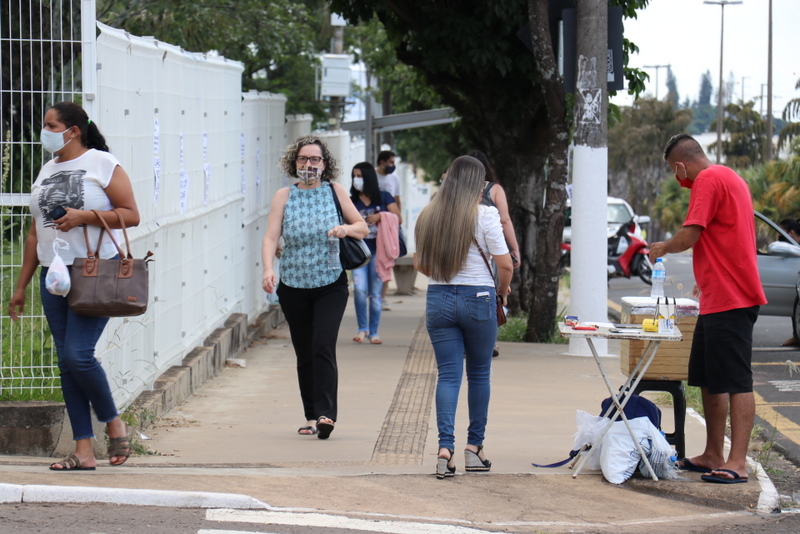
[350,161,402,345]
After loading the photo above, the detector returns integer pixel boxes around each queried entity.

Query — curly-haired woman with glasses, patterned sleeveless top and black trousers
[261,135,369,439]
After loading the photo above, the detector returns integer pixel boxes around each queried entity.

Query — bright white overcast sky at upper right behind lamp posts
[612,0,800,116]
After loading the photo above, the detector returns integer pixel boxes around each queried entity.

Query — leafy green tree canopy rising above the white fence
[97,0,331,120]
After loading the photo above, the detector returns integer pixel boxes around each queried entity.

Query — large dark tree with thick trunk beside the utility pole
[331,0,647,341]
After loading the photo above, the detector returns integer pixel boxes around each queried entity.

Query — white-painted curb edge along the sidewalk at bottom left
[0,483,270,510]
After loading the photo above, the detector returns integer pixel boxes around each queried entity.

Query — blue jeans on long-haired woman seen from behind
[425,285,497,449]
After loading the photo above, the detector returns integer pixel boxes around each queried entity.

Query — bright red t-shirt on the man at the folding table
[683,165,767,315]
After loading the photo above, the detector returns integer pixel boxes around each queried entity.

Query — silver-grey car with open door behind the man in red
[754,211,800,322]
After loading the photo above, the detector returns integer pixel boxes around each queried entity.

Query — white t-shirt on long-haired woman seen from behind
[428,205,508,286]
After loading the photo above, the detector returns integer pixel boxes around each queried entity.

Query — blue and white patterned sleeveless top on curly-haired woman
[281,182,342,289]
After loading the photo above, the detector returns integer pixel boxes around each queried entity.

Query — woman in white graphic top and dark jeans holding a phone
[8,102,139,471]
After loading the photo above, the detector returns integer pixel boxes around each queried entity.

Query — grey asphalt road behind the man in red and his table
[608,254,800,465]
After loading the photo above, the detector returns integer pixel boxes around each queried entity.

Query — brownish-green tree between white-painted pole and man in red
[608,98,692,241]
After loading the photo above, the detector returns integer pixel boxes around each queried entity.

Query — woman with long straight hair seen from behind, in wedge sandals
[414,156,513,479]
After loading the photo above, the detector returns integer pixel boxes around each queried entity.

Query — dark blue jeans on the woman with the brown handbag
[40,267,119,440]
